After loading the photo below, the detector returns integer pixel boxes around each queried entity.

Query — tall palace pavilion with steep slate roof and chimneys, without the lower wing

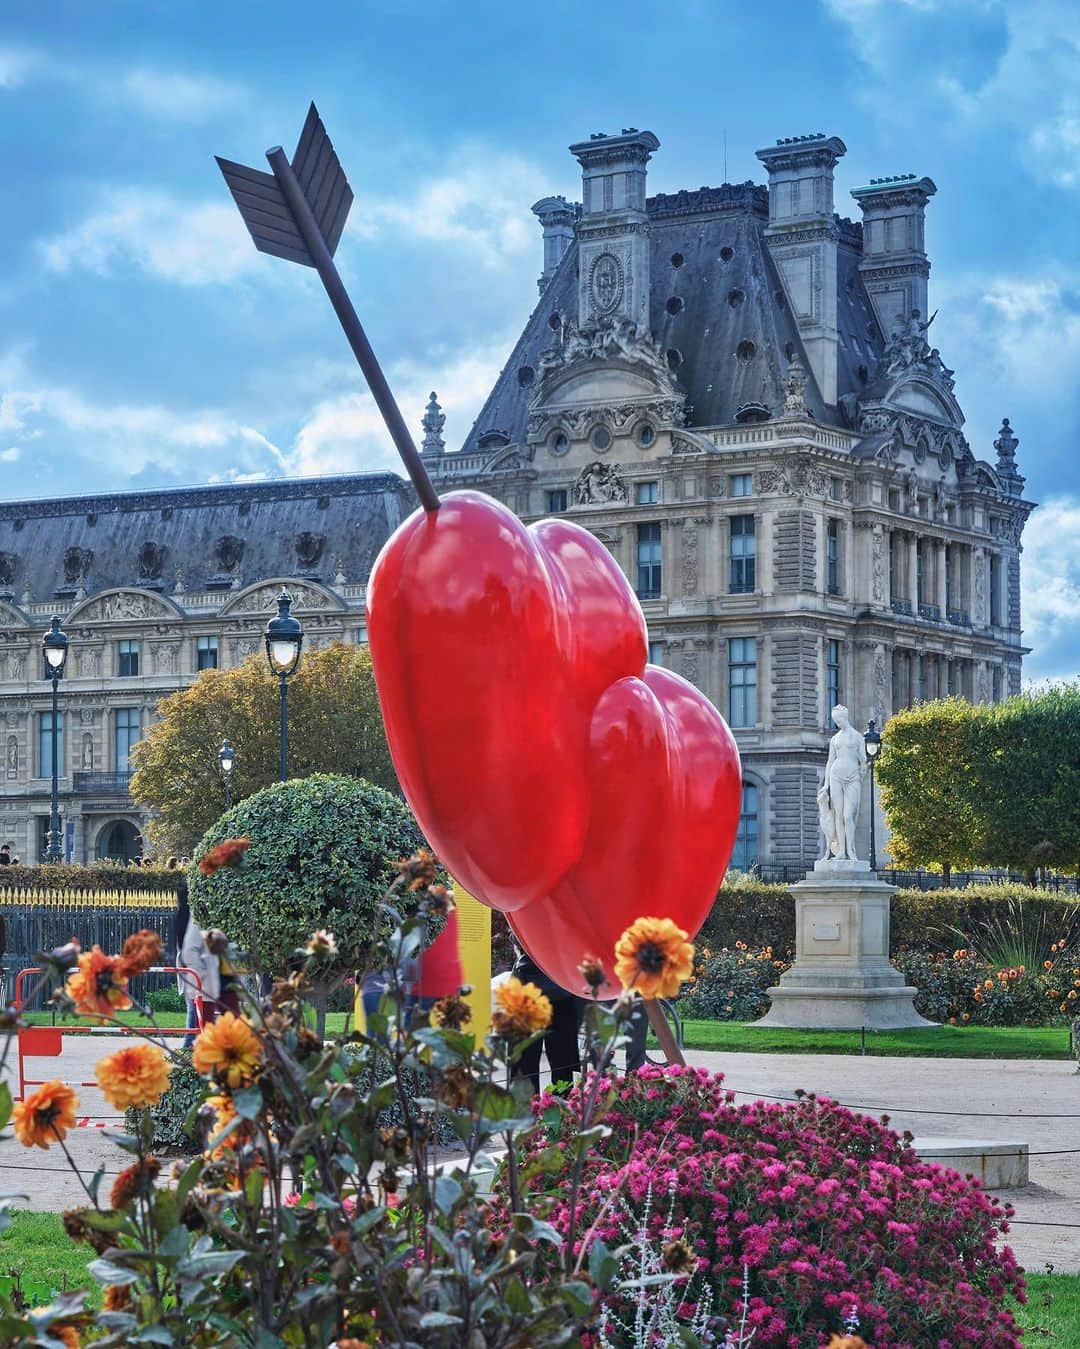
[426,131,1031,871]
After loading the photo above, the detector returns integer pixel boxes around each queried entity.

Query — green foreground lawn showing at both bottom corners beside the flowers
[0,1213,1080,1349]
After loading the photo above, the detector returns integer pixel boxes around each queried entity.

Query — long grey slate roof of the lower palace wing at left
[0,473,415,604]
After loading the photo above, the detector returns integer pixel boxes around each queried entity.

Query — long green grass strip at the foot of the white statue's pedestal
[682,1021,1071,1059]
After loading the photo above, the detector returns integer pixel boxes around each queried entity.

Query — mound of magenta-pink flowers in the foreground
[512,1068,1025,1349]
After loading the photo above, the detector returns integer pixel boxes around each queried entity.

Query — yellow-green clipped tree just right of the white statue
[876,697,983,884]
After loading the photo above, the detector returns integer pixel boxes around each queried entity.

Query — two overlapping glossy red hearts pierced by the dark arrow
[367,491,742,992]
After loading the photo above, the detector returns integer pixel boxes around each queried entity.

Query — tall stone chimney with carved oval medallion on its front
[570,127,659,333]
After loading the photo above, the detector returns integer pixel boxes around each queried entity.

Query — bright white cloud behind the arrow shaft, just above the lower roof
[287,340,511,478]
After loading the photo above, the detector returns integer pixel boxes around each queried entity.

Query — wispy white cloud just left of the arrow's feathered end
[38,188,258,286]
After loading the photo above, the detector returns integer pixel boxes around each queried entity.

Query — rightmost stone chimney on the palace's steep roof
[852,173,937,339]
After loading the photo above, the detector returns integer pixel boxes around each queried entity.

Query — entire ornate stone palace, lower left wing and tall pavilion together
[0,128,1031,869]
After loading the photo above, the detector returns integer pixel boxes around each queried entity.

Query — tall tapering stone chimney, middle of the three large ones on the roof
[758,131,847,403]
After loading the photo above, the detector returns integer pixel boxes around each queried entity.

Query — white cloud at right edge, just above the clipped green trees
[1021,496,1080,679]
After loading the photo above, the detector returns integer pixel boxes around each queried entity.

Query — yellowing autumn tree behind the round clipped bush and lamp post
[131,642,396,854]
